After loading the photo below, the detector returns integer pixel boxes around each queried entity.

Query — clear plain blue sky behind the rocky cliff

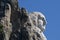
[19,0,60,40]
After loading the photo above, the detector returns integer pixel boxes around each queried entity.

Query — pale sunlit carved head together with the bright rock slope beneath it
[29,12,47,40]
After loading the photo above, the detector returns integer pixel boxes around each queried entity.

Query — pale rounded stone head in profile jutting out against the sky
[30,12,47,31]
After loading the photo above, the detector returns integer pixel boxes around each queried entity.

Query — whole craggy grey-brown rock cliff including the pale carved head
[0,0,47,40]
